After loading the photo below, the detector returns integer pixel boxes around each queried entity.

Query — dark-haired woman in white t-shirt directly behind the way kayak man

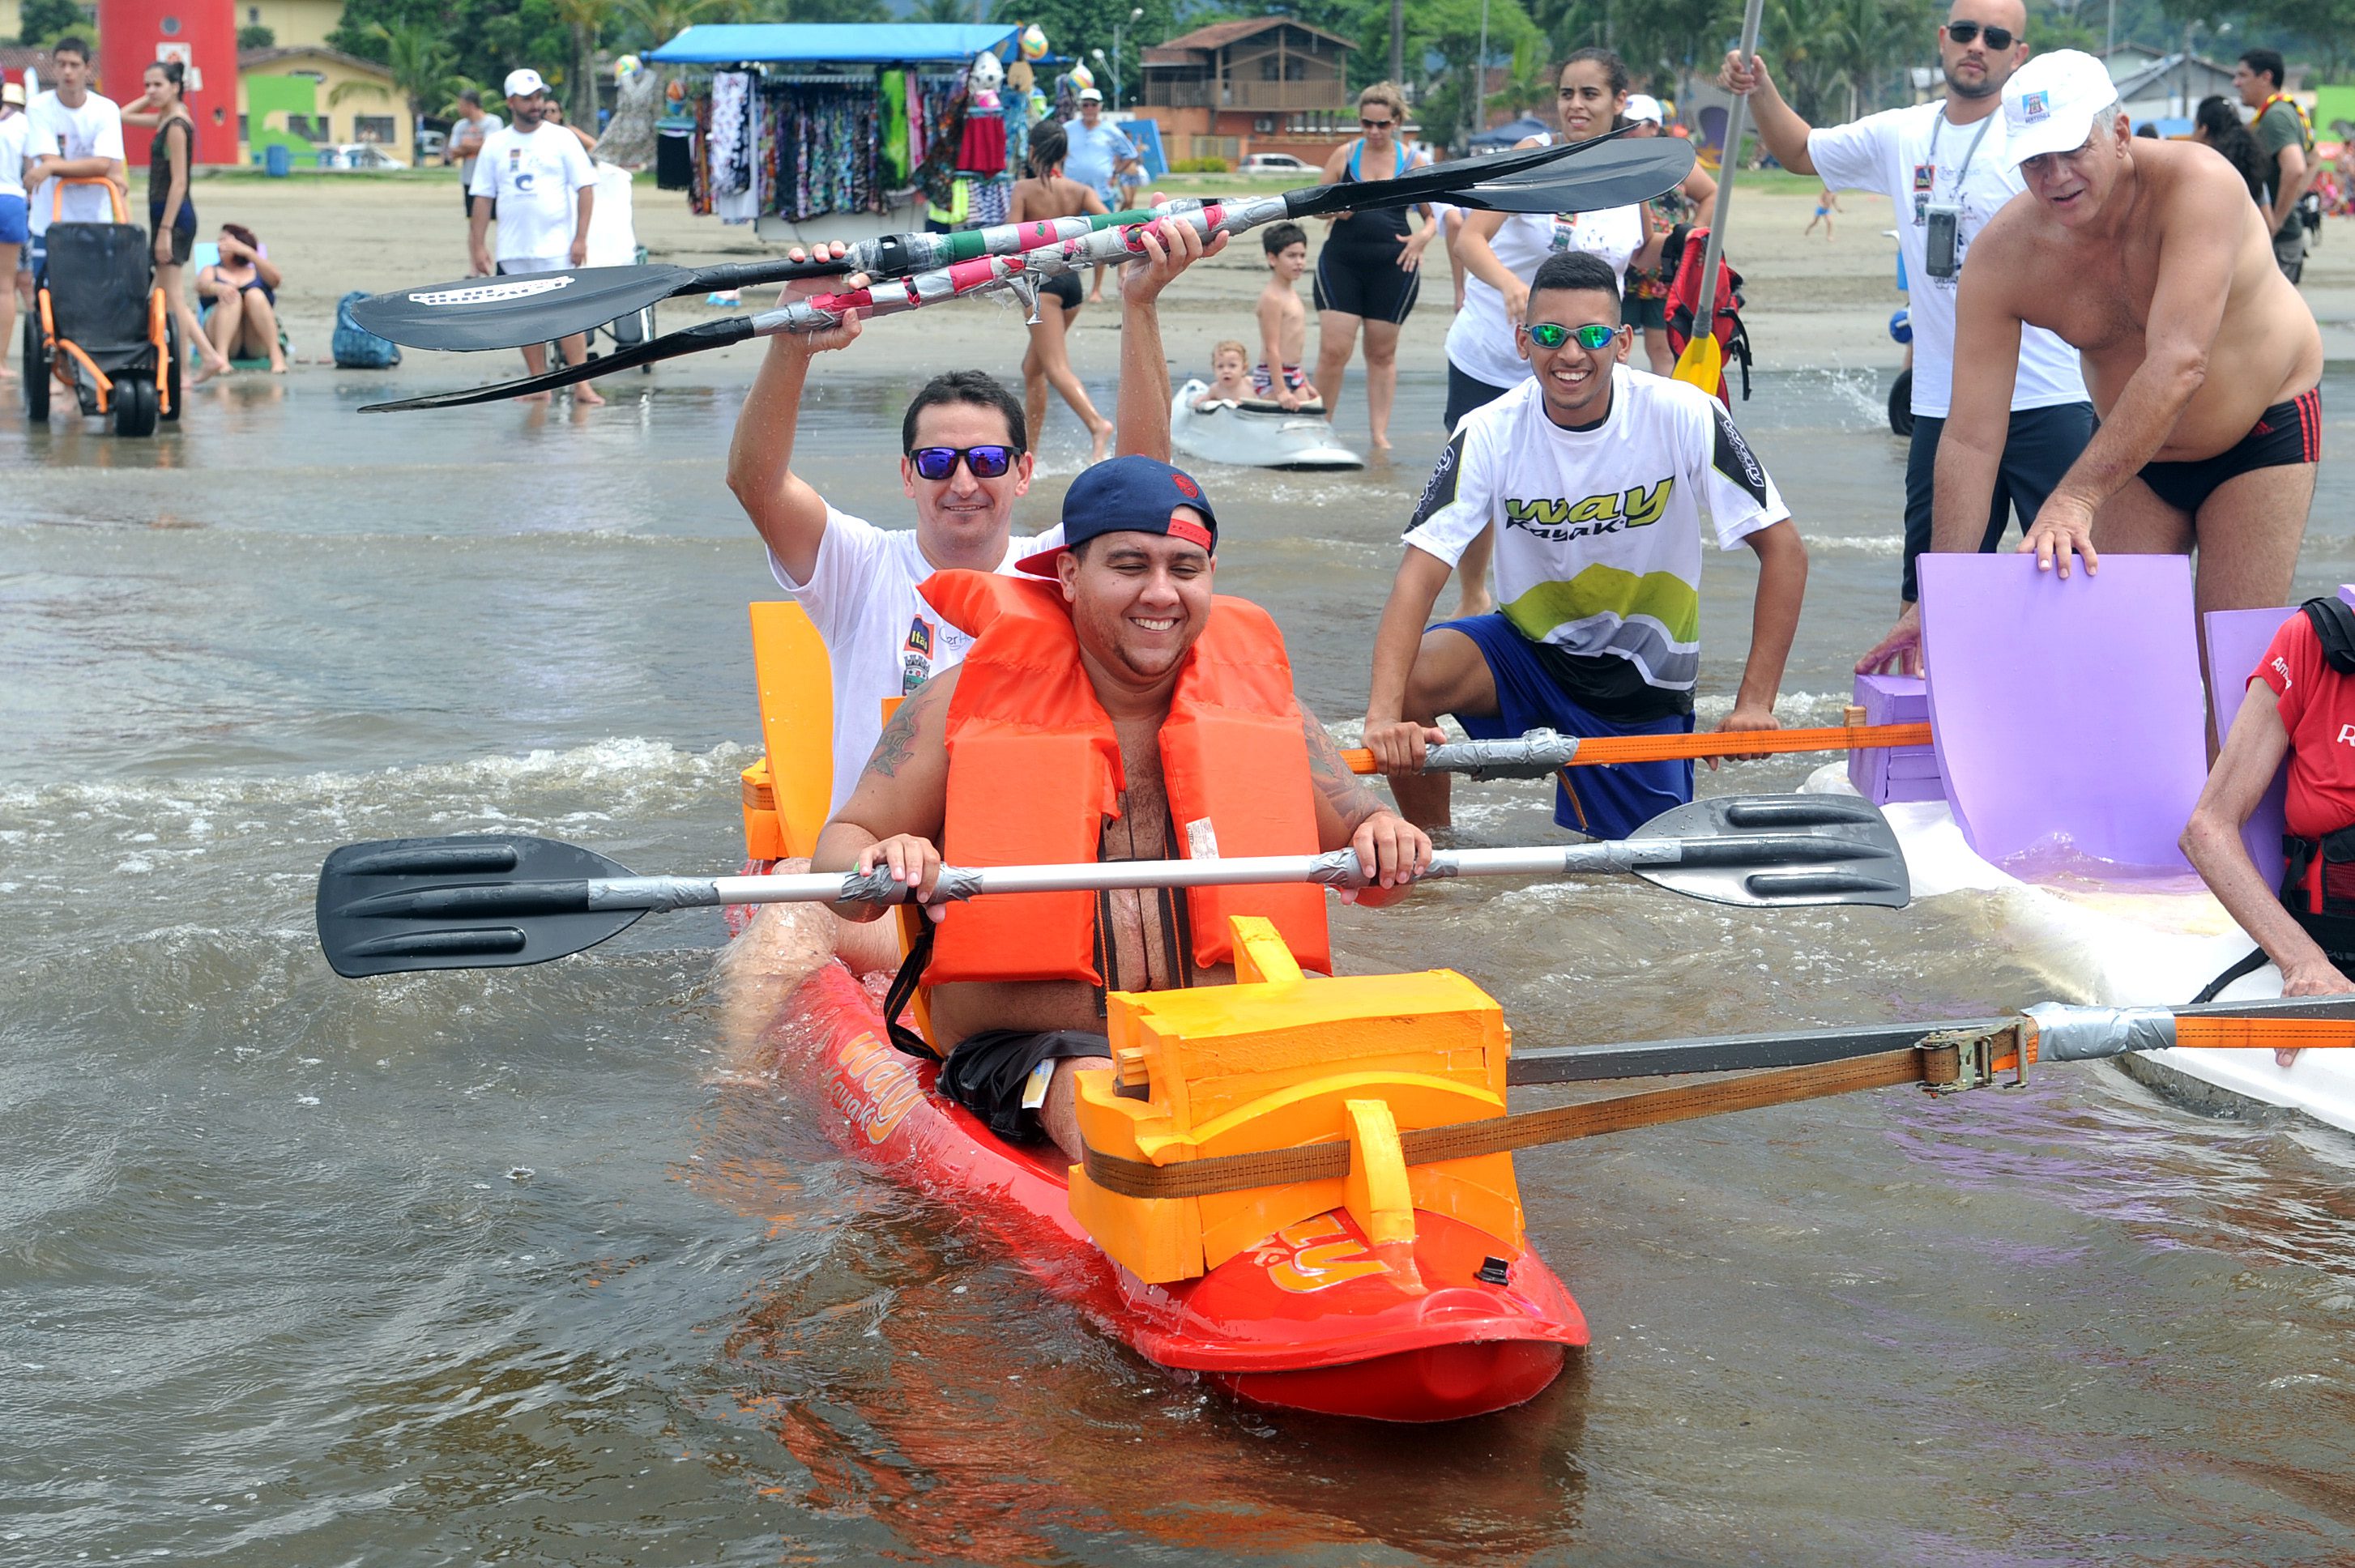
[1446,49,1662,615]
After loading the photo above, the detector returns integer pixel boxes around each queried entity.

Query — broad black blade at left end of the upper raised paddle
[351,262,850,353]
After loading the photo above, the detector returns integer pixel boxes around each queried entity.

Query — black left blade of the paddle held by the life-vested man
[318,833,646,979]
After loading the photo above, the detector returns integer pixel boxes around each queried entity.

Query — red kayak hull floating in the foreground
[766,963,1587,1422]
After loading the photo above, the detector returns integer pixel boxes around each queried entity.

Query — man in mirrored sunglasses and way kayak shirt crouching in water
[1366,252,1807,838]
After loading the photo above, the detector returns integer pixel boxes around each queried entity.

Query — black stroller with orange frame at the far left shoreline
[23,179,179,436]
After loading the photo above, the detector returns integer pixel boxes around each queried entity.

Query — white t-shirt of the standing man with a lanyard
[1807,101,2087,419]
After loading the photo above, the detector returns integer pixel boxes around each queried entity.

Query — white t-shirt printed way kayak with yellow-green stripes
[1406,365,1790,695]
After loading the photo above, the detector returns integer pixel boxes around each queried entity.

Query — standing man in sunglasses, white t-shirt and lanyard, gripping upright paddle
[1717,0,2093,673]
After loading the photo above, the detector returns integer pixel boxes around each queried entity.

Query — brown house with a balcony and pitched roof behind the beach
[1135,16,1356,167]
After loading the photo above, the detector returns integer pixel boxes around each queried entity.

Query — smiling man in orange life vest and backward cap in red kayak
[810,457,1431,1158]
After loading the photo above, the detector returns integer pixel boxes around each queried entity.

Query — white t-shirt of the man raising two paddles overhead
[772,510,1062,817]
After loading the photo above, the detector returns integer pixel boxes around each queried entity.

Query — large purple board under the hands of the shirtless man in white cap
[1919,553,2207,871]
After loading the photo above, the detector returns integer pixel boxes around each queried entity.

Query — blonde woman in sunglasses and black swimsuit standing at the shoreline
[1316,83,1439,450]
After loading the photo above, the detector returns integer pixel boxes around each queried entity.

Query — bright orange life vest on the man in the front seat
[919,572,1333,986]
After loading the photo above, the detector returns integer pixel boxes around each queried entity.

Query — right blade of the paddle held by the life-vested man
[1628,795,1912,909]
